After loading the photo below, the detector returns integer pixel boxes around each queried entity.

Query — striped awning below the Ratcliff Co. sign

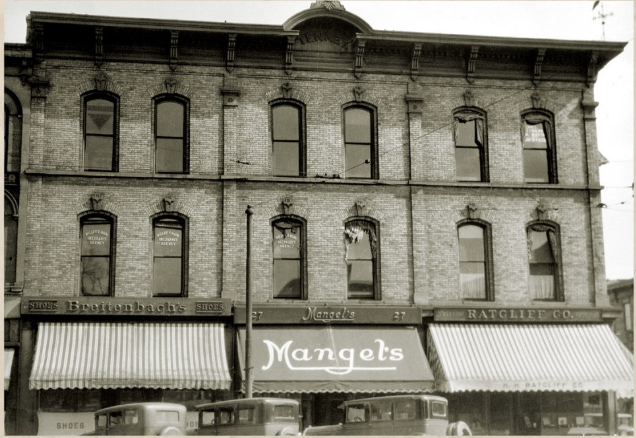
[428,324,634,392]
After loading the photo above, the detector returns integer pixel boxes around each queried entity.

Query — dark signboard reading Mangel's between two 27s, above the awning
[234,305,422,325]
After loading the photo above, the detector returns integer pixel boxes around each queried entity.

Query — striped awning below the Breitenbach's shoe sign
[29,323,231,389]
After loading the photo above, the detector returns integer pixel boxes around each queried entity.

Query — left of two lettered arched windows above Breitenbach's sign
[80,214,115,296]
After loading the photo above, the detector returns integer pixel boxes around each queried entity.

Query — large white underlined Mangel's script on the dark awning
[262,339,404,375]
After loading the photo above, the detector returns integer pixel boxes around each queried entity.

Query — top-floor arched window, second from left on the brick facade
[155,96,190,173]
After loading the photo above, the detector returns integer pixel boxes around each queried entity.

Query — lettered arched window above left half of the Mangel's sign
[272,218,306,299]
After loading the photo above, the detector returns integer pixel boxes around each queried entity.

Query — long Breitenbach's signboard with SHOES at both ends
[22,297,232,316]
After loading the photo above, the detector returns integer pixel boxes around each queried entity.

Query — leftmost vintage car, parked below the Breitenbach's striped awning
[84,402,186,435]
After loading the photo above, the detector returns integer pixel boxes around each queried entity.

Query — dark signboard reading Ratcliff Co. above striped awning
[434,308,602,323]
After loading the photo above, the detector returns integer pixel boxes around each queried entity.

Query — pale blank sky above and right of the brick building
[4,0,634,279]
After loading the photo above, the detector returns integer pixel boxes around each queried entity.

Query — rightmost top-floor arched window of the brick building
[521,110,557,184]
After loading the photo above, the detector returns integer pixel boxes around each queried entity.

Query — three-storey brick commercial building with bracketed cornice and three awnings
[5,1,633,435]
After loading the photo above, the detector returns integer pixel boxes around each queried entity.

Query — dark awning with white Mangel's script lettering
[239,327,435,393]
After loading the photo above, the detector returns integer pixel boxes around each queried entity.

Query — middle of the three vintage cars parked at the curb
[196,397,299,436]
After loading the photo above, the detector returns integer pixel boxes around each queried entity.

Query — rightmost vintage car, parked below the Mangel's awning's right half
[303,395,472,436]
